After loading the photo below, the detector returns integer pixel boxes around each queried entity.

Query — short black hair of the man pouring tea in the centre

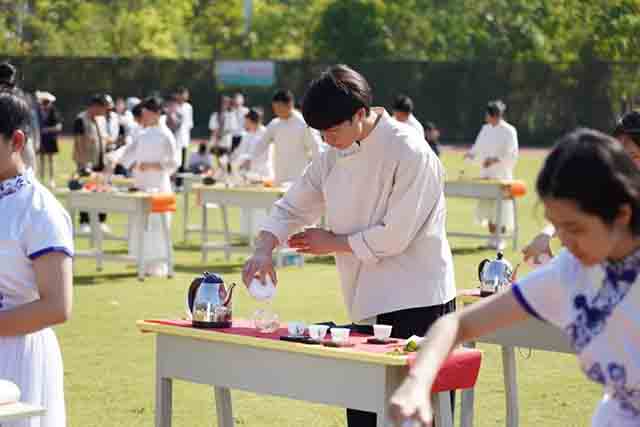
[302,64,373,130]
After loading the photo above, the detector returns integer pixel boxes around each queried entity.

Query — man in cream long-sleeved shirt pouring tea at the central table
[243,65,456,427]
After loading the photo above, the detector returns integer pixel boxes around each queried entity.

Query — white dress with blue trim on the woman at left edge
[0,171,74,427]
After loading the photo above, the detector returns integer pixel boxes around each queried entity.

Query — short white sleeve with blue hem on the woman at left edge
[23,197,74,260]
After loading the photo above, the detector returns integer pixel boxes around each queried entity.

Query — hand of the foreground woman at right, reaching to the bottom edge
[390,376,433,427]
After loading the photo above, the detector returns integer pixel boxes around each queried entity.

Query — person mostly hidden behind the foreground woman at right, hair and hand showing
[522,111,640,264]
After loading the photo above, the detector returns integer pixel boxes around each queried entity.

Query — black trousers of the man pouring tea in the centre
[347,298,456,427]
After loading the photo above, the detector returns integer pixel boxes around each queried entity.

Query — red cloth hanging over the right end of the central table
[409,349,482,393]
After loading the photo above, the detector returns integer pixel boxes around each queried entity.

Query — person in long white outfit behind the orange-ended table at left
[120,97,178,276]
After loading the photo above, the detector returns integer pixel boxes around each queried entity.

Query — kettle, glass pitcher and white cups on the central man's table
[186,272,397,347]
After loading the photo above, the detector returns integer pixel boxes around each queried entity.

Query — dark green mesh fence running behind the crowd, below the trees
[7,57,640,146]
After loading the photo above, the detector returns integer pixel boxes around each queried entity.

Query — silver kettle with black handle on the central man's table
[186,272,236,328]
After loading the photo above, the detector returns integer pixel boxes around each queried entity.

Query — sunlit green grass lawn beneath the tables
[45,140,601,427]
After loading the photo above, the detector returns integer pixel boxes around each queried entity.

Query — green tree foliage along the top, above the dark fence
[0,0,640,63]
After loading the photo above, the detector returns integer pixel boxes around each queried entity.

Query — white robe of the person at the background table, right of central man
[471,120,518,230]
